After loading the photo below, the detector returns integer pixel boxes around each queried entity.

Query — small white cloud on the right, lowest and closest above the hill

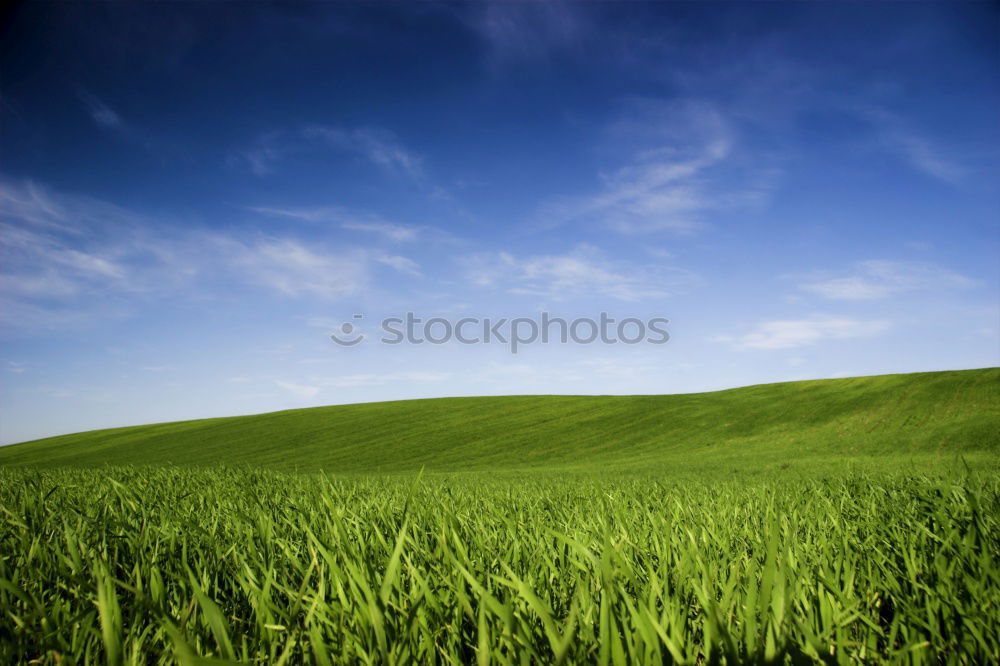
[711,316,889,349]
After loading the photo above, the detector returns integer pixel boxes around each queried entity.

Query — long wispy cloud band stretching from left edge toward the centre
[0,179,420,330]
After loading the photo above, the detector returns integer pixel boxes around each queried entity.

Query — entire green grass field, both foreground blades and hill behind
[0,369,1000,665]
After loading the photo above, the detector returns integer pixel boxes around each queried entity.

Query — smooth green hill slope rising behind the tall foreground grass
[0,368,1000,473]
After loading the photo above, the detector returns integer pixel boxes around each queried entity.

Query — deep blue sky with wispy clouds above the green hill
[0,3,1000,443]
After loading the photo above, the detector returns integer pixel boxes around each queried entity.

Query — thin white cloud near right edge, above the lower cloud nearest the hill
[799,260,975,301]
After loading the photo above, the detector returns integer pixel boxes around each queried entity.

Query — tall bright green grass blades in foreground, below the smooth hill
[0,468,1000,664]
